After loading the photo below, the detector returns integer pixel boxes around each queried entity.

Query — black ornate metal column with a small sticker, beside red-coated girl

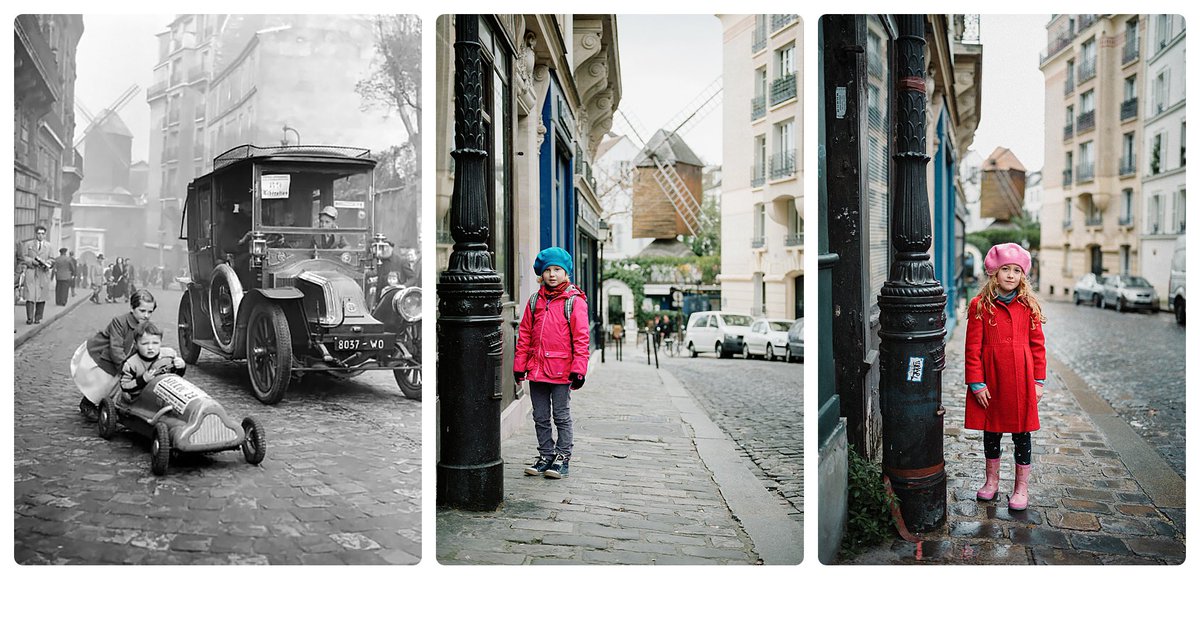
[878,16,946,531]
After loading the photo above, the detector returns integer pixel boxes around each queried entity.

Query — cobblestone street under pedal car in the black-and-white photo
[14,290,421,564]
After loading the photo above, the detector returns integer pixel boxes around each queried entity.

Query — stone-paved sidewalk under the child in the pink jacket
[437,359,802,565]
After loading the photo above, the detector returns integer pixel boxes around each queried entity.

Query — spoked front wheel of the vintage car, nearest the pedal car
[246,303,292,404]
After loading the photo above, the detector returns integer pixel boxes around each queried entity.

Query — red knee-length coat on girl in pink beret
[965,297,1046,432]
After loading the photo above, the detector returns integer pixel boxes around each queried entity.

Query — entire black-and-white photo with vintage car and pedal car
[13,14,422,565]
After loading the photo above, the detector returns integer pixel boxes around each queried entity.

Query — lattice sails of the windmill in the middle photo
[601,76,724,235]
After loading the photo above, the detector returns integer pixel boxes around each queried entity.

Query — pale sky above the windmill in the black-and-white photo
[76,14,174,162]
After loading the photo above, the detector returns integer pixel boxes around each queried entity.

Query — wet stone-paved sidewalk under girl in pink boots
[848,321,1186,565]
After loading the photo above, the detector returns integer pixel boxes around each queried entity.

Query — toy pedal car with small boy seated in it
[97,374,266,476]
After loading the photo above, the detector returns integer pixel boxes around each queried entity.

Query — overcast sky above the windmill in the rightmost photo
[971,14,1050,173]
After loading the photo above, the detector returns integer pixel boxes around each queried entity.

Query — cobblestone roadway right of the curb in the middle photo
[659,351,804,522]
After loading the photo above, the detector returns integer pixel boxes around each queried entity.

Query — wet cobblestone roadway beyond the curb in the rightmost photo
[1045,303,1187,476]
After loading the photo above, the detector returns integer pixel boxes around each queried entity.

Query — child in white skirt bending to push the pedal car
[71,290,158,421]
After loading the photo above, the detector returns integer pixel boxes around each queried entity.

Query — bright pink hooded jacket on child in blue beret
[512,285,588,384]
